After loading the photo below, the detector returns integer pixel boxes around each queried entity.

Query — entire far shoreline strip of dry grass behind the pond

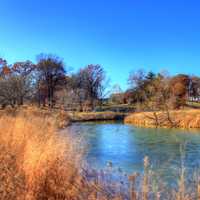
[4,106,200,129]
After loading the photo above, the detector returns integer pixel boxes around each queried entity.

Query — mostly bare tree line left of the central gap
[0,54,105,111]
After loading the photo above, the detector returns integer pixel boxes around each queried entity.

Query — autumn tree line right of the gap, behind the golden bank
[111,69,200,110]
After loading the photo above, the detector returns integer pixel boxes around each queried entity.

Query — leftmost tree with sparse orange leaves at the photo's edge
[0,61,34,107]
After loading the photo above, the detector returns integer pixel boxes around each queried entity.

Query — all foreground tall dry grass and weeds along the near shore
[0,112,200,200]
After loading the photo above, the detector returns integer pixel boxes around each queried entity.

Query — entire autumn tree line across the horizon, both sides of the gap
[0,54,200,111]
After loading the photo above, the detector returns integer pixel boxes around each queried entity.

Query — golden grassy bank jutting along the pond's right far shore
[124,109,200,129]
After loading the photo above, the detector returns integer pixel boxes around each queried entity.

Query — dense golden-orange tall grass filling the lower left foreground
[0,113,80,199]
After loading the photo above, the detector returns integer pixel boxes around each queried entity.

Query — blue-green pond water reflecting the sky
[65,123,200,184]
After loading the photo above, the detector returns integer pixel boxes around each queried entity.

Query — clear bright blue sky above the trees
[0,0,200,89]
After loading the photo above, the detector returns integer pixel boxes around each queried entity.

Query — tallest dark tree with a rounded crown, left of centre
[37,54,66,107]
